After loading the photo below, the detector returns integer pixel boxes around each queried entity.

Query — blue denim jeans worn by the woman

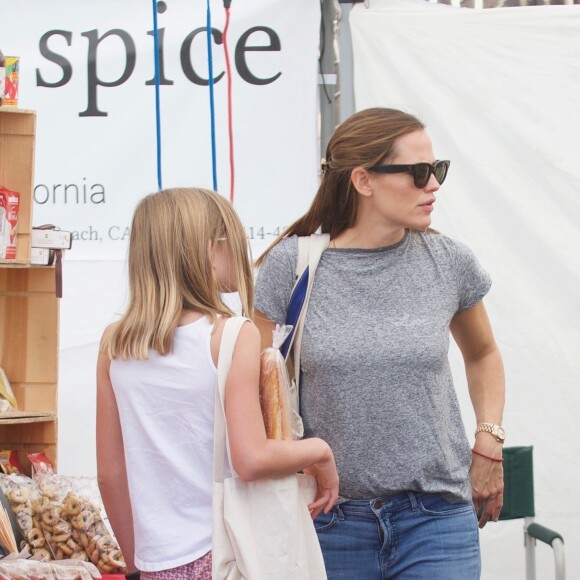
[314,492,481,580]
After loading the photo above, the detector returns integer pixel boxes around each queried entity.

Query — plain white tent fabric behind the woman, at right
[350,0,580,580]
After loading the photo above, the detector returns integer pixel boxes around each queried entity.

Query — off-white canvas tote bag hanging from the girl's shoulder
[212,317,326,580]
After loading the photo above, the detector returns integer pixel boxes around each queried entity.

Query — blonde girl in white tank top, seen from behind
[97,188,338,580]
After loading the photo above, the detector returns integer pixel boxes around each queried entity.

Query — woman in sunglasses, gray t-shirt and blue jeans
[255,108,504,580]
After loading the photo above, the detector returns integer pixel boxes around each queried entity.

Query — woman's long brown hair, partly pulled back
[256,107,425,266]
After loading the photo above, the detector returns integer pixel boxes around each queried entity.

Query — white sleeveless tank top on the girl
[110,317,217,572]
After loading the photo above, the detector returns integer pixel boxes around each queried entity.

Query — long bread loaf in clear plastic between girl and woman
[260,324,292,440]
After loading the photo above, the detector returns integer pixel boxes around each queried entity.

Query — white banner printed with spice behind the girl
[0,0,320,260]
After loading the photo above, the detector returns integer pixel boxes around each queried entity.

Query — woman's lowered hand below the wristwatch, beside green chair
[469,437,503,528]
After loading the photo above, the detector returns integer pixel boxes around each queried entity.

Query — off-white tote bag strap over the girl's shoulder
[213,316,248,482]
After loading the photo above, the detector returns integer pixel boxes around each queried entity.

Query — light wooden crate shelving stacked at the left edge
[0,107,59,474]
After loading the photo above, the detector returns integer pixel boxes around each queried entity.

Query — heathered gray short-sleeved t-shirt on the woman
[256,232,491,501]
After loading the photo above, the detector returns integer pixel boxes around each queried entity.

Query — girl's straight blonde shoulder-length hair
[102,188,254,360]
